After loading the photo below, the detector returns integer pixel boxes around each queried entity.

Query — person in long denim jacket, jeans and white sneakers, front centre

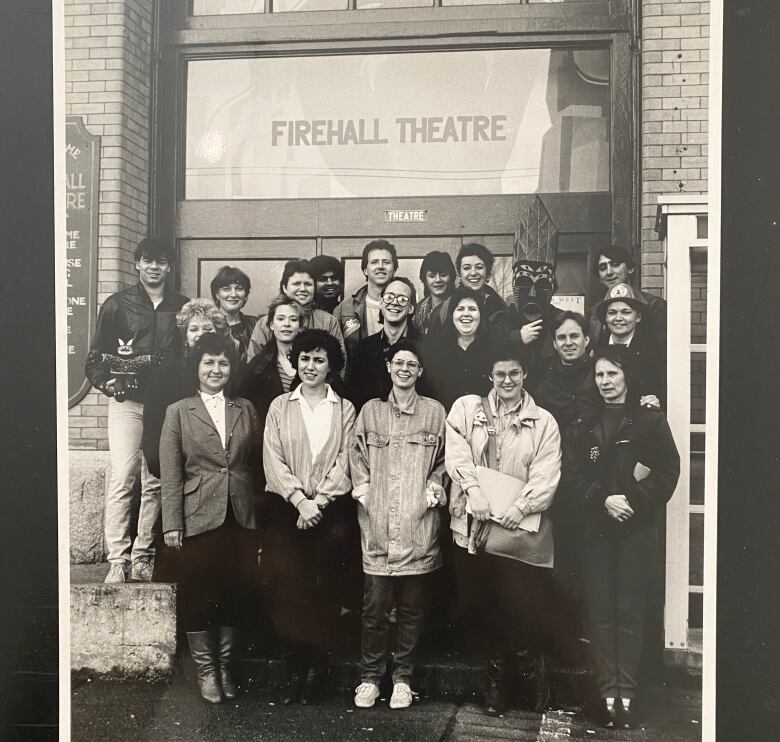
[349,340,447,709]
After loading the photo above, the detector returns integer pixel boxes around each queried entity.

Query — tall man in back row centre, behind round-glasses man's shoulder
[333,240,398,366]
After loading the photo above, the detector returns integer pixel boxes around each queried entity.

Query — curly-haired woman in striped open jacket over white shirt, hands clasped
[263,330,360,703]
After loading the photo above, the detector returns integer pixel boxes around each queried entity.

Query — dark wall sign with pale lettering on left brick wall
[65,116,100,407]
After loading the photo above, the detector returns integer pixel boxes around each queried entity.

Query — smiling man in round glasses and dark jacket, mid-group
[347,277,424,412]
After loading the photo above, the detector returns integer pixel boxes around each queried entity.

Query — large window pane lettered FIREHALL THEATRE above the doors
[185,49,609,201]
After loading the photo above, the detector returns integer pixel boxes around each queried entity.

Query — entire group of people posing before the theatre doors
[86,238,679,727]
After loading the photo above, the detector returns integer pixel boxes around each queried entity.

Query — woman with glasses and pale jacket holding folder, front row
[445,344,561,716]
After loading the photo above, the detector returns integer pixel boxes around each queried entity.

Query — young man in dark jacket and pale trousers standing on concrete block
[84,237,189,582]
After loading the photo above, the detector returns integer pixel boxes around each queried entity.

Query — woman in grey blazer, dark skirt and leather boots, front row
[160,334,260,703]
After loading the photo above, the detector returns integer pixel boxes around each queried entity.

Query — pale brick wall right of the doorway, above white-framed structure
[641,0,710,294]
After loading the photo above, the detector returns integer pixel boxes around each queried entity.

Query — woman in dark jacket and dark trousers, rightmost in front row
[563,345,680,729]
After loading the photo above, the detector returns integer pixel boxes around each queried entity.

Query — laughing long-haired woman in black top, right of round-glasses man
[424,286,492,410]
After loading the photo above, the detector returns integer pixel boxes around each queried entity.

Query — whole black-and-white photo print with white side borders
[54,0,721,742]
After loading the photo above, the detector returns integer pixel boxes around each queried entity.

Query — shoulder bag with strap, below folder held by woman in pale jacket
[482,397,554,567]
